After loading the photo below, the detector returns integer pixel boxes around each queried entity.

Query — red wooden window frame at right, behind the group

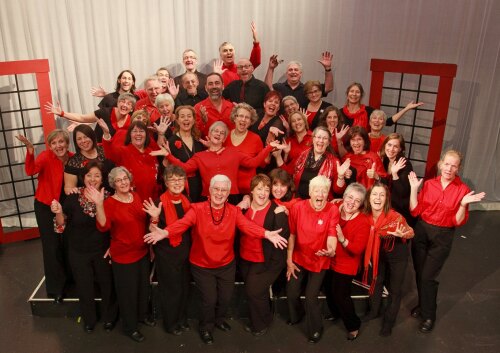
[370,59,457,178]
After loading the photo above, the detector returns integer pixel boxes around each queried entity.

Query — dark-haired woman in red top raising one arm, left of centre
[99,120,160,200]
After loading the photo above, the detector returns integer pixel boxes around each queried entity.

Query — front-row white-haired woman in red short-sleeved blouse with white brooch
[286,175,339,343]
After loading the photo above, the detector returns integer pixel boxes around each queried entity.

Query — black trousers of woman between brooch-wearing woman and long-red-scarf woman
[330,271,361,332]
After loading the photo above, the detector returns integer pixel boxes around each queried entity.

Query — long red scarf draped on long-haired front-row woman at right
[363,209,413,295]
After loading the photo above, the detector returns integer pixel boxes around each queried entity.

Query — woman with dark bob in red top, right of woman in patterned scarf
[344,126,387,188]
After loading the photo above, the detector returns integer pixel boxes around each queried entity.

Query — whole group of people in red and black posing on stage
[17,24,484,344]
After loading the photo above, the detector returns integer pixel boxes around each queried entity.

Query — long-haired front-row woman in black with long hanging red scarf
[363,183,414,337]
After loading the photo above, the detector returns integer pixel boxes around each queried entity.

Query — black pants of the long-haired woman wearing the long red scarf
[370,239,409,327]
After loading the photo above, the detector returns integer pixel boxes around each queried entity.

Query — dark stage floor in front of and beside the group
[0,211,500,353]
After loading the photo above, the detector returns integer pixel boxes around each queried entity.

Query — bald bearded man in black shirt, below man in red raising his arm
[222,59,269,116]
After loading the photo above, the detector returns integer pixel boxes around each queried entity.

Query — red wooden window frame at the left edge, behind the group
[0,59,56,244]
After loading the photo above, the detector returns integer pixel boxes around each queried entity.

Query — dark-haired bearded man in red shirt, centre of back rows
[194,72,234,136]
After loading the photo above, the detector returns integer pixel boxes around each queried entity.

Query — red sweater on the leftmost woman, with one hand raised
[24,150,74,206]
